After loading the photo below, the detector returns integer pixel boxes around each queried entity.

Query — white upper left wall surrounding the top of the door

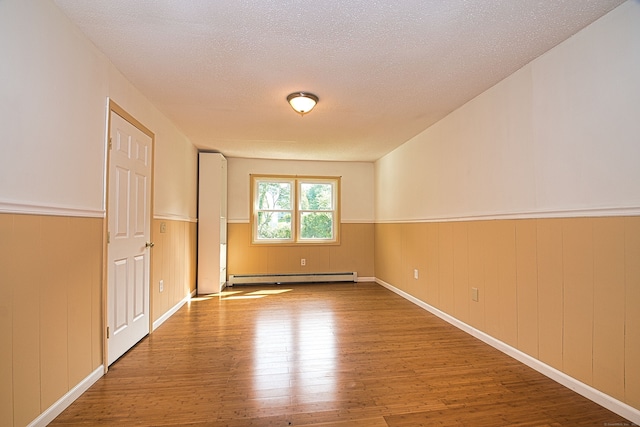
[0,0,197,218]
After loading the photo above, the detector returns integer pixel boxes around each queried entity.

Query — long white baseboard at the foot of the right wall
[375,278,640,425]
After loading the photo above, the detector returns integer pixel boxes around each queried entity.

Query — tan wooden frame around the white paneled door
[102,98,156,374]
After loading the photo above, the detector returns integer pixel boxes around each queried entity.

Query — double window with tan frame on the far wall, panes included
[251,175,340,244]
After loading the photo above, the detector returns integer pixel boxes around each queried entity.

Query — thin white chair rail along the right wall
[376,206,640,224]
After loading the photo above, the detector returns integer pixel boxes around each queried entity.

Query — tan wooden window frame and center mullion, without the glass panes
[249,174,342,246]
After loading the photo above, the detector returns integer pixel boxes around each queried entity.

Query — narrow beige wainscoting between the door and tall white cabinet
[151,219,198,322]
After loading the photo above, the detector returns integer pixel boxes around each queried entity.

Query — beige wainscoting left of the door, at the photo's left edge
[0,214,103,426]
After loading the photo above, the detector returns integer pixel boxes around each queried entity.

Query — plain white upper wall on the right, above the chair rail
[375,0,640,222]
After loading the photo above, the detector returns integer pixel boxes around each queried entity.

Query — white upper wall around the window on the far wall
[227,158,374,222]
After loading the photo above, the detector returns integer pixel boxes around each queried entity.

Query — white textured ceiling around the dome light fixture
[54,0,623,161]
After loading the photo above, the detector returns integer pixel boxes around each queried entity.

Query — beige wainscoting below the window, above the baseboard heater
[227,223,374,277]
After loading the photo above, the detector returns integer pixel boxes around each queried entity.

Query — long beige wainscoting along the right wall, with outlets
[375,217,640,409]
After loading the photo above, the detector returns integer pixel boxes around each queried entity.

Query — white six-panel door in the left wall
[107,112,153,365]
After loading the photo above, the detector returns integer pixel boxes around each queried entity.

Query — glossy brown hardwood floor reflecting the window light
[51,283,631,427]
